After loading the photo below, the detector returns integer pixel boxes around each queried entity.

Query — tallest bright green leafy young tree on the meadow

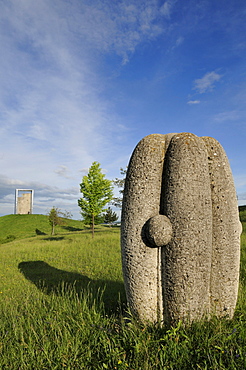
[78,162,113,237]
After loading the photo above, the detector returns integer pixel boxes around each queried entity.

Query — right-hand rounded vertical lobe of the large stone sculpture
[202,137,242,318]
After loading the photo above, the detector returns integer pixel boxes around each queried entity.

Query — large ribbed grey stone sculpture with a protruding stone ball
[121,133,241,325]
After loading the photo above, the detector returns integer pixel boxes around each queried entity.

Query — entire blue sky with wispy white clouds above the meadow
[0,0,246,219]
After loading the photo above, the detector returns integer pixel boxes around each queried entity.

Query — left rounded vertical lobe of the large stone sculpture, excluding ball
[121,134,175,322]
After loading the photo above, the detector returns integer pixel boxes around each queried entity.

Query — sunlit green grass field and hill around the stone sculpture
[0,209,246,370]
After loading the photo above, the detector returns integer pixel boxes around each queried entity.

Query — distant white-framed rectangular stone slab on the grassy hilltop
[15,189,34,215]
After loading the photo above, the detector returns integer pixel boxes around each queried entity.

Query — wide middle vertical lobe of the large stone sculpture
[162,133,212,322]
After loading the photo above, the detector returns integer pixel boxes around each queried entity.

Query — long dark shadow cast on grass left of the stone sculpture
[18,261,126,313]
